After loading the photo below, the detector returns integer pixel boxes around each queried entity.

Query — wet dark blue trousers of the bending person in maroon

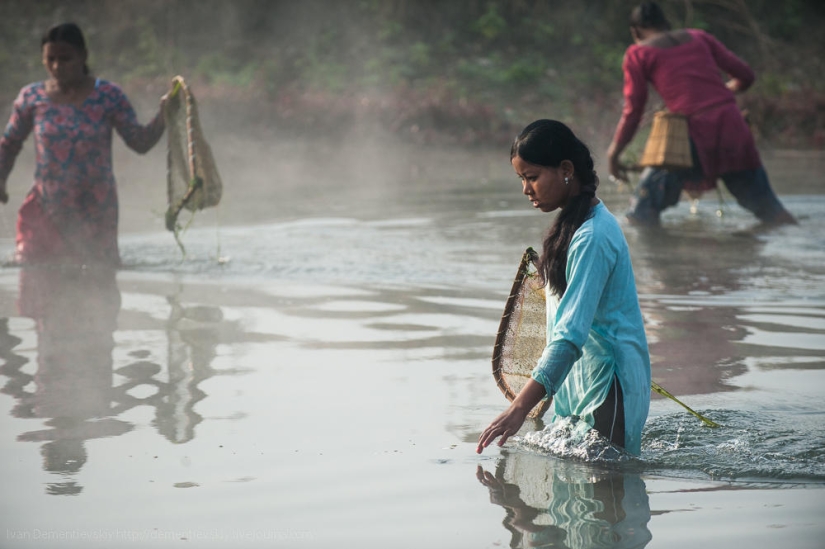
[627,143,793,225]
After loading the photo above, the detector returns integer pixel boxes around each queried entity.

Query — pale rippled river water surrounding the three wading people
[0,140,825,548]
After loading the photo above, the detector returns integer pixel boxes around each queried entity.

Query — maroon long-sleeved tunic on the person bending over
[614,29,762,191]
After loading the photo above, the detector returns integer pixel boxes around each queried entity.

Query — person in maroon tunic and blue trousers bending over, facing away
[607,2,796,224]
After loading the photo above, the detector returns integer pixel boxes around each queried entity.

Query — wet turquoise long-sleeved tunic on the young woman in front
[532,203,650,455]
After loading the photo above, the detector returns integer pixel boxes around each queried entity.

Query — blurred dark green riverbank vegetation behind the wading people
[0,0,825,149]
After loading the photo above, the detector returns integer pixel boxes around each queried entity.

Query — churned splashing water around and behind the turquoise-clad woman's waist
[511,410,825,486]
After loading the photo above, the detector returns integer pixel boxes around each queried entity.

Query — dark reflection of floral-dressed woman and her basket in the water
[0,266,232,495]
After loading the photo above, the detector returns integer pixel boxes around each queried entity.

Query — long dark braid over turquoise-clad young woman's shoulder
[539,139,598,297]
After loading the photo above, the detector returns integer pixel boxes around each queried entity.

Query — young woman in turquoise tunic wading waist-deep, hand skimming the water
[477,120,650,454]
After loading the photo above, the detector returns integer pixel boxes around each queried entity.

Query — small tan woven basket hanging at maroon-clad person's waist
[639,111,693,170]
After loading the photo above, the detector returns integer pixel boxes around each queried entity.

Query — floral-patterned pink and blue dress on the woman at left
[0,79,164,265]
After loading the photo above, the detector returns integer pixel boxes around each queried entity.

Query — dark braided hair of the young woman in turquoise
[510,120,599,296]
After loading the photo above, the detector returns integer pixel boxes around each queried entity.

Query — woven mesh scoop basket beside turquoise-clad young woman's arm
[493,248,550,418]
